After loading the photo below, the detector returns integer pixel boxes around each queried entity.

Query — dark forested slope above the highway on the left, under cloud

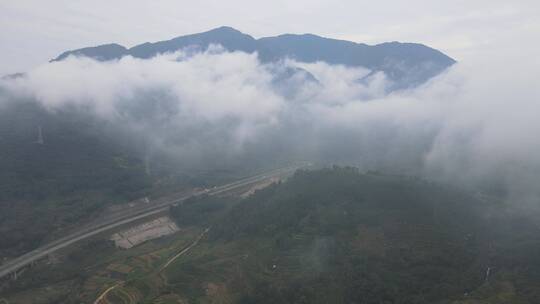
[0,100,260,261]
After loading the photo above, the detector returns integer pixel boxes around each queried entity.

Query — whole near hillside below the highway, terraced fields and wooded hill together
[5,167,540,304]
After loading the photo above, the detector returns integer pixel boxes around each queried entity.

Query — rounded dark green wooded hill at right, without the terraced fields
[167,168,540,304]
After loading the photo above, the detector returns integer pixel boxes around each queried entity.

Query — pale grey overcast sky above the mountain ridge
[0,0,540,74]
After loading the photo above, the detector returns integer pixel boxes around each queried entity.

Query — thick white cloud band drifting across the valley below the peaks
[2,47,540,202]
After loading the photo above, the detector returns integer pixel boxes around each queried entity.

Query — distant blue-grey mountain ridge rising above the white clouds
[51,27,456,89]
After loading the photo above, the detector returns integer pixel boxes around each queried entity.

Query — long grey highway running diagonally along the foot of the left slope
[0,166,302,278]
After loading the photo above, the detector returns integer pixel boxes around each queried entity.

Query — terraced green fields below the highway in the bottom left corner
[1,222,201,304]
